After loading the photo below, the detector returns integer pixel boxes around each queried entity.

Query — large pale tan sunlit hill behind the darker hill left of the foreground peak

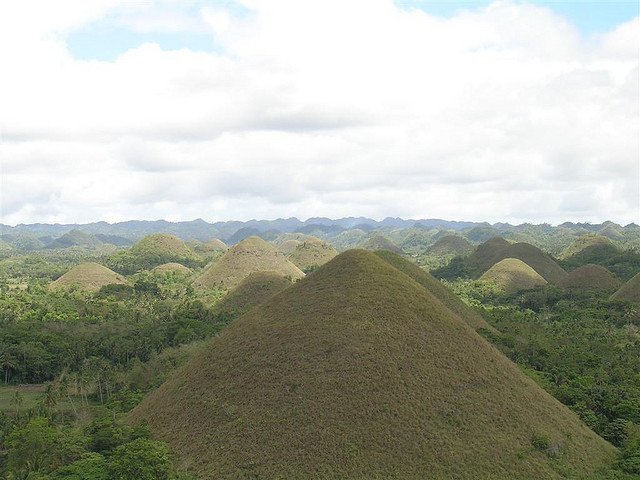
[194,237,304,289]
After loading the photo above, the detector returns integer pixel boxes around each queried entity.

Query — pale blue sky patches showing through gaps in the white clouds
[66,0,640,61]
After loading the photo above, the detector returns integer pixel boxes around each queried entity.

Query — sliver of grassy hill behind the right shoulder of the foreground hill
[376,251,495,332]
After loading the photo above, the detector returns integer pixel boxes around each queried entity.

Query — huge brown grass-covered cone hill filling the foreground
[129,250,615,480]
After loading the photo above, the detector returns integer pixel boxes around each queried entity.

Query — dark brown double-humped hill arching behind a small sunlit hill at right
[469,237,567,285]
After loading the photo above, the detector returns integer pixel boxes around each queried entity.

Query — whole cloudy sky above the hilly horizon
[0,0,640,225]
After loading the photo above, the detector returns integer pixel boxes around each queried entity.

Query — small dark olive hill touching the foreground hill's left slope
[213,272,293,318]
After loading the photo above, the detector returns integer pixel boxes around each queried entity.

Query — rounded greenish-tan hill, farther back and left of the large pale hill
[129,233,198,268]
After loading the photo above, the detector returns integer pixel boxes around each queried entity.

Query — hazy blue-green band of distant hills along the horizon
[0,217,640,256]
